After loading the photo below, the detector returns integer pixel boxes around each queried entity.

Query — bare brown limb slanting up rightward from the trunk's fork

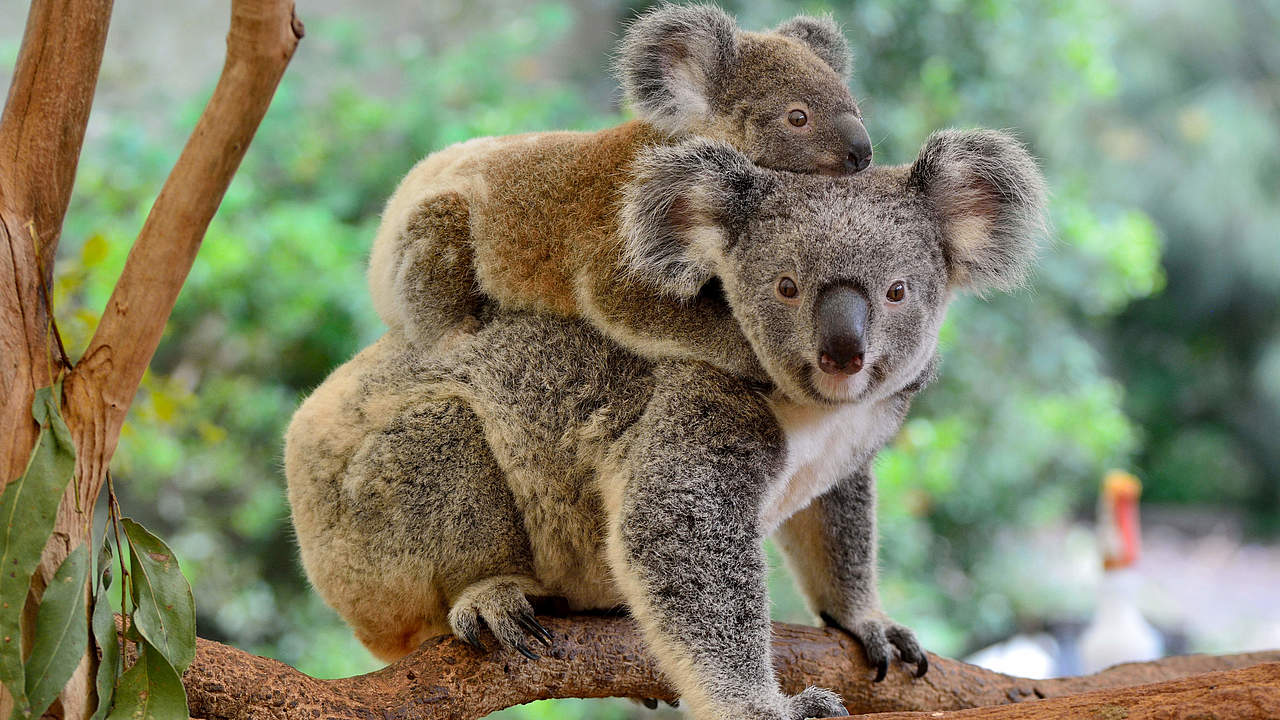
[67,0,303,509]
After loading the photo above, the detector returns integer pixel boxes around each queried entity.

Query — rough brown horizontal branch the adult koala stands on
[183,616,1280,720]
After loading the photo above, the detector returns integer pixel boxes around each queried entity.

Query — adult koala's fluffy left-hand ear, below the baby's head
[620,140,777,300]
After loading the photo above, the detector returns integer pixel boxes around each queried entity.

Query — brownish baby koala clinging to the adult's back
[369,4,872,379]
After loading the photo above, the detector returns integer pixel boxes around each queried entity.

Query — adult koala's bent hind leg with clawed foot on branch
[335,398,547,661]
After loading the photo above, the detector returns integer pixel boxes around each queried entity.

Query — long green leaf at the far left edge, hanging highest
[0,383,76,717]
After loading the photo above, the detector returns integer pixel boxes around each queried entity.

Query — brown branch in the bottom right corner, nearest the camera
[858,662,1280,720]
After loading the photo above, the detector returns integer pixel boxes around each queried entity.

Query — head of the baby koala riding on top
[617,4,872,176]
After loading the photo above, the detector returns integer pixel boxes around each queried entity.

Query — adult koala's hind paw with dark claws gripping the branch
[449,578,552,660]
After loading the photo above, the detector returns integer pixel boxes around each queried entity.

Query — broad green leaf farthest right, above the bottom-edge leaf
[120,518,196,673]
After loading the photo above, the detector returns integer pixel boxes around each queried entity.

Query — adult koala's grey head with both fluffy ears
[621,131,1044,404]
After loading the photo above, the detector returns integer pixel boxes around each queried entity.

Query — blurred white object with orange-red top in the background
[1080,470,1165,673]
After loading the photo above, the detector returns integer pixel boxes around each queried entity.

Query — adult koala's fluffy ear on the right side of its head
[908,129,1046,291]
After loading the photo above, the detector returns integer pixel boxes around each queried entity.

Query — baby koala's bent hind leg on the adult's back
[370,192,483,348]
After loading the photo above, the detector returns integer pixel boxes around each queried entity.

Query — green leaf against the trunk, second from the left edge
[24,544,88,716]
